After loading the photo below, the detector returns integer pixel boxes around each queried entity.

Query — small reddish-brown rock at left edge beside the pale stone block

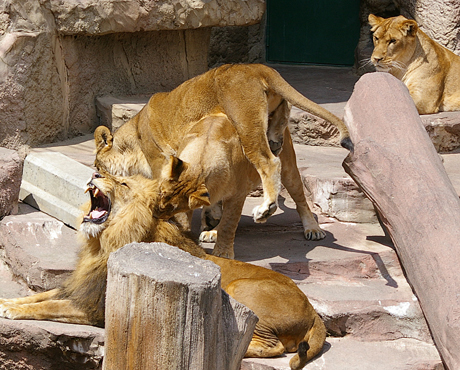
[0,147,23,219]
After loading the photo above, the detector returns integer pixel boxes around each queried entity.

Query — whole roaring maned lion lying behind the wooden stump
[0,174,326,369]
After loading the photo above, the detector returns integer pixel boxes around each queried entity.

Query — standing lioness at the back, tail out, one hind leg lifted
[95,64,352,228]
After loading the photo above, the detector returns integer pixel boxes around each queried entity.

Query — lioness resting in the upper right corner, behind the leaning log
[369,14,460,114]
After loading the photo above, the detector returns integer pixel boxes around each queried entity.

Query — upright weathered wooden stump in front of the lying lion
[103,243,257,370]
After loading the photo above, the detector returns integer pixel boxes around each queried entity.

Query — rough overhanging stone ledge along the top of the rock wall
[0,0,265,36]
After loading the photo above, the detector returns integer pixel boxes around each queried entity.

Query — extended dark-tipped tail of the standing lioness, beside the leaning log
[265,67,353,151]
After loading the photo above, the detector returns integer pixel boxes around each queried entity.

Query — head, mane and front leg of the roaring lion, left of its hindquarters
[0,174,209,326]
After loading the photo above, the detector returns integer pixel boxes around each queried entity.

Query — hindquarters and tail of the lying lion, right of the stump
[206,255,326,370]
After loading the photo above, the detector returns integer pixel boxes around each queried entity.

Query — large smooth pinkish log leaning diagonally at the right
[343,73,460,370]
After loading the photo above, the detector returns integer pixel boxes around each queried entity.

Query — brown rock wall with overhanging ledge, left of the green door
[0,0,265,148]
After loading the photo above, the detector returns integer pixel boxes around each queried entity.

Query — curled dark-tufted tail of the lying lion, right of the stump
[289,315,326,370]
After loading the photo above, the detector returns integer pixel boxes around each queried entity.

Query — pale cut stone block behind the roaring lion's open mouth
[19,152,93,228]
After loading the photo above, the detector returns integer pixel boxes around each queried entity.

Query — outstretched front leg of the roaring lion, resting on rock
[0,299,93,325]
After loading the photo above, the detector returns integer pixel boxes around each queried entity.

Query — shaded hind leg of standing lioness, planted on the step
[280,128,326,240]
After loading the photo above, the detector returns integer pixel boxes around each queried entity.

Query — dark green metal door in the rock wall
[266,0,360,65]
